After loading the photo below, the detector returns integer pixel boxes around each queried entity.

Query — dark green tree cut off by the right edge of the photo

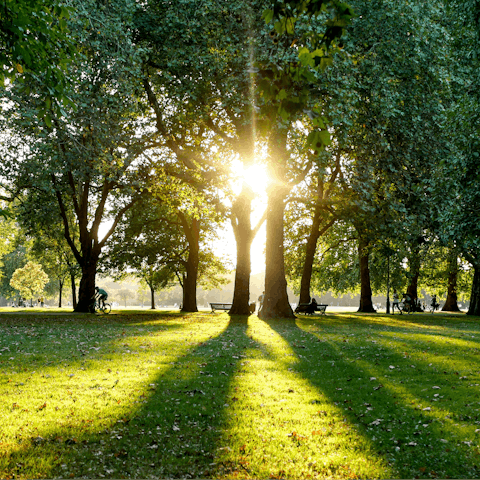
[432,0,480,315]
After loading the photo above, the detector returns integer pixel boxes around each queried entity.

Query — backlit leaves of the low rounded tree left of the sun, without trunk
[102,192,227,291]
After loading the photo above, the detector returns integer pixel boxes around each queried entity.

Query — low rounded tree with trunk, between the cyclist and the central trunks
[102,189,226,311]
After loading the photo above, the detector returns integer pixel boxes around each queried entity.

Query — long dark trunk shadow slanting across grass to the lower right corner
[267,320,480,478]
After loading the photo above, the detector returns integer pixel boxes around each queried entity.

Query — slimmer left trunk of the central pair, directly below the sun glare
[229,183,254,315]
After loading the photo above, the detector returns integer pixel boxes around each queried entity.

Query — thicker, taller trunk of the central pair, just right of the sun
[260,130,295,319]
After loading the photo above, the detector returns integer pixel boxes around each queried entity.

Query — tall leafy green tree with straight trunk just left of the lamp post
[284,1,449,311]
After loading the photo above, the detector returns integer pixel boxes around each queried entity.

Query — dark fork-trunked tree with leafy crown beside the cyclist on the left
[3,0,154,312]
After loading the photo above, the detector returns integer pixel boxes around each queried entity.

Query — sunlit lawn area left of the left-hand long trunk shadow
[0,318,226,478]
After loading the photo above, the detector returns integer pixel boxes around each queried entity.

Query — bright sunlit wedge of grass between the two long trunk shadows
[217,316,392,479]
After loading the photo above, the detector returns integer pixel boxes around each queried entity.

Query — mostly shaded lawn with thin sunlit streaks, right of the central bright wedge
[300,318,480,478]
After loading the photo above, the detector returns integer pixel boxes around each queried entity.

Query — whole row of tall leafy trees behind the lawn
[0,0,480,318]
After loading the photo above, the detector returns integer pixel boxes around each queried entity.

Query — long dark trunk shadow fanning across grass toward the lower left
[0,319,249,479]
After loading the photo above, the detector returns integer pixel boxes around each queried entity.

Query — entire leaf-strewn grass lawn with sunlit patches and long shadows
[0,310,480,480]
